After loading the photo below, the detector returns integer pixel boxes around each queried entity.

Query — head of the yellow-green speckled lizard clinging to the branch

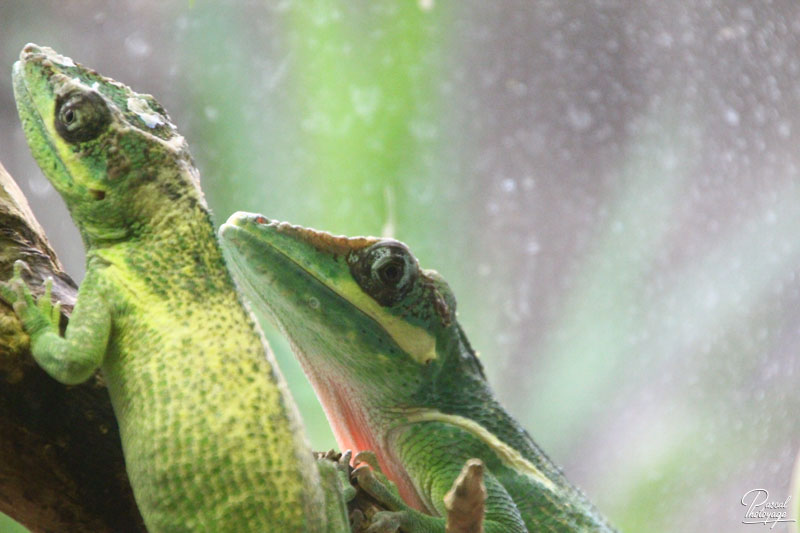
[13,44,205,242]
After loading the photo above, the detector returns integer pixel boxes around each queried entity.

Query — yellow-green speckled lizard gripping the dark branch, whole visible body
[2,44,349,533]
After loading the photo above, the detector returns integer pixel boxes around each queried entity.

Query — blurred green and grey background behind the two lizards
[0,0,800,532]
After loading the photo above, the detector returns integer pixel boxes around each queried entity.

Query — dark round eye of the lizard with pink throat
[351,241,419,306]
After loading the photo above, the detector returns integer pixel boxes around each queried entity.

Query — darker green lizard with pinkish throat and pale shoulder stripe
[221,213,612,533]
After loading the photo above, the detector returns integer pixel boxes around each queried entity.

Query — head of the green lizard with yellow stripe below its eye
[221,213,481,407]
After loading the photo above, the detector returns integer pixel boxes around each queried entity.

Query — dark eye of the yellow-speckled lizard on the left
[55,91,111,143]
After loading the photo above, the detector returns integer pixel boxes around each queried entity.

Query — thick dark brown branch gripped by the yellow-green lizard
[0,164,146,533]
